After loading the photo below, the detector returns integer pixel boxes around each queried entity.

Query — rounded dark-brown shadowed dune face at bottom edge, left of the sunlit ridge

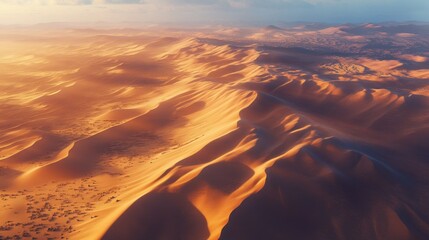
[104,193,209,239]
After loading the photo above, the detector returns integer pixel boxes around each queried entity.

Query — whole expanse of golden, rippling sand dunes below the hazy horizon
[0,26,429,240]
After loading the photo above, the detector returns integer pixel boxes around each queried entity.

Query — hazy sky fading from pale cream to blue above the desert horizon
[0,0,429,25]
